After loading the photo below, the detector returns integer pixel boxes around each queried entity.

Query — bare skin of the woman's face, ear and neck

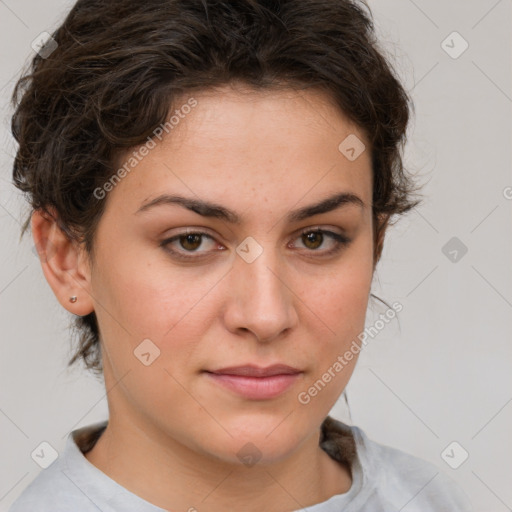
[32,86,388,512]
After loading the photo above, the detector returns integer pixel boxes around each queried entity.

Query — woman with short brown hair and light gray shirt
[11,0,470,512]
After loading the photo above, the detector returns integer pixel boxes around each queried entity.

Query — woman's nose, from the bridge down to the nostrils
[224,244,298,343]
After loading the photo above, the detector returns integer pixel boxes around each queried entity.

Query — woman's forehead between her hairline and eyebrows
[109,86,372,218]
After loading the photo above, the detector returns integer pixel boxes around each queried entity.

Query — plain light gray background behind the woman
[0,0,512,512]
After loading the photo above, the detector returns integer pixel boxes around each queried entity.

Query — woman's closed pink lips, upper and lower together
[205,364,303,400]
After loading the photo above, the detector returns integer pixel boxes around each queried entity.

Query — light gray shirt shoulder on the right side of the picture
[351,427,473,512]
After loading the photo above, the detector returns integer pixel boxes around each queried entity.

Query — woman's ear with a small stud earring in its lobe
[31,210,94,316]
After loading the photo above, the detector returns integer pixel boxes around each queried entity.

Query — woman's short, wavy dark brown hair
[12,0,421,374]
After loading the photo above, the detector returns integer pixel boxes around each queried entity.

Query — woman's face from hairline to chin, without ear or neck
[89,87,374,463]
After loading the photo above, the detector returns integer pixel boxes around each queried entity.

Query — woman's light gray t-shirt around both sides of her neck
[9,416,473,512]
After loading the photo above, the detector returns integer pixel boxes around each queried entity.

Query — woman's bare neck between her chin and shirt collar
[85,415,351,512]
